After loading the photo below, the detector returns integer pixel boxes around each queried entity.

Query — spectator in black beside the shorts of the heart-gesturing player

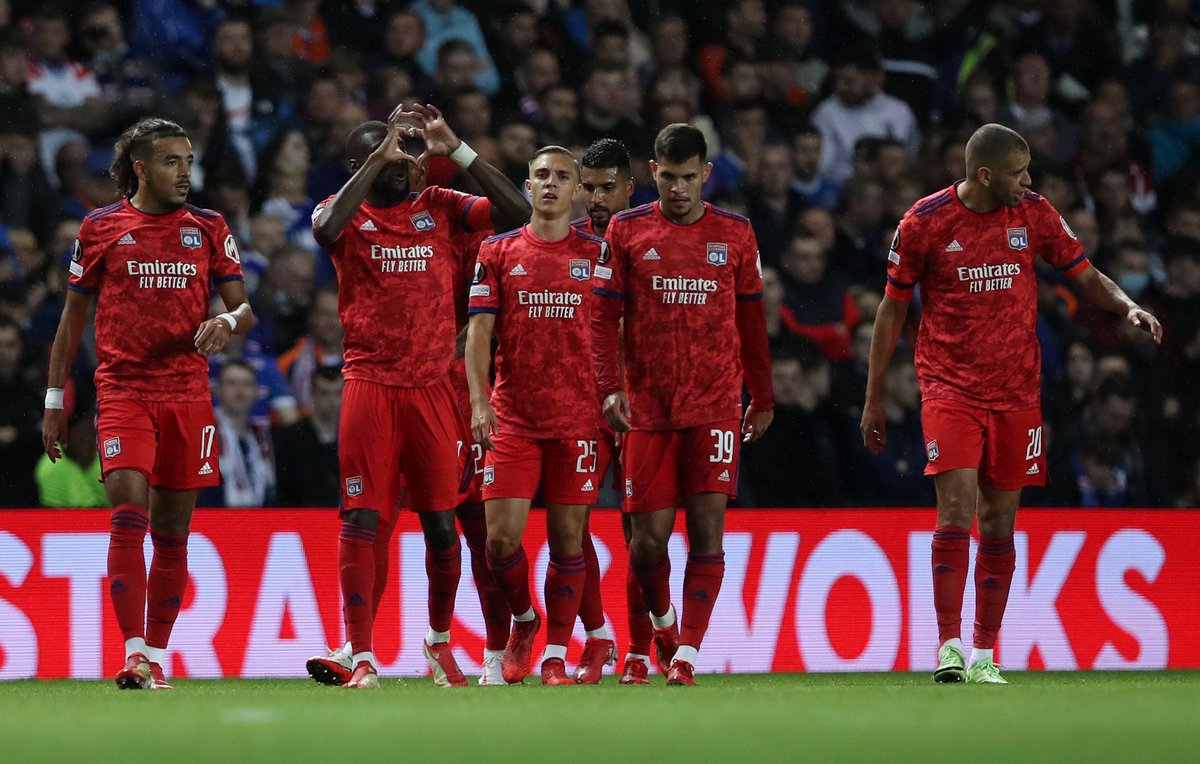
[272,364,346,507]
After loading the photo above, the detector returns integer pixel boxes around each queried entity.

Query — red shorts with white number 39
[620,419,742,512]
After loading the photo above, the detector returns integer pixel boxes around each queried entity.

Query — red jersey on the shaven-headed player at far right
[886,186,1090,410]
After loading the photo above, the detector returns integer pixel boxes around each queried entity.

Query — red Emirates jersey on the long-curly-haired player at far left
[68,199,241,402]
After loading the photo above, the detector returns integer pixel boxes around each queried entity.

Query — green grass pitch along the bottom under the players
[0,672,1200,764]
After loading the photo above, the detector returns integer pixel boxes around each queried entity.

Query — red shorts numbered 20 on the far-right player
[920,401,1046,491]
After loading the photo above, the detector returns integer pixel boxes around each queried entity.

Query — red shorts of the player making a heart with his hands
[337,379,467,516]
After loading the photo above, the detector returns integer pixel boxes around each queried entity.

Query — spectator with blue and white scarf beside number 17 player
[197,361,275,507]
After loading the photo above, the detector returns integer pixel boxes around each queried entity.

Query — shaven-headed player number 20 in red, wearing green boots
[860,125,1163,685]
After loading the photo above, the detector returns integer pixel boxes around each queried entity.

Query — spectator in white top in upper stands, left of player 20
[812,50,920,182]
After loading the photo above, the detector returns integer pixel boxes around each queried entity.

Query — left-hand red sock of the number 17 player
[108,504,150,639]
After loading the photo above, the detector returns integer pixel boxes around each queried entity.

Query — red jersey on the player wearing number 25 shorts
[469,225,605,440]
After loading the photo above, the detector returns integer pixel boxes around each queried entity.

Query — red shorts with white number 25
[484,434,602,505]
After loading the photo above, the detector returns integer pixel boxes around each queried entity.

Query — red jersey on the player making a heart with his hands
[313,186,492,387]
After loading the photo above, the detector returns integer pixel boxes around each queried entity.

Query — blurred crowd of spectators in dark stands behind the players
[0,0,1200,507]
